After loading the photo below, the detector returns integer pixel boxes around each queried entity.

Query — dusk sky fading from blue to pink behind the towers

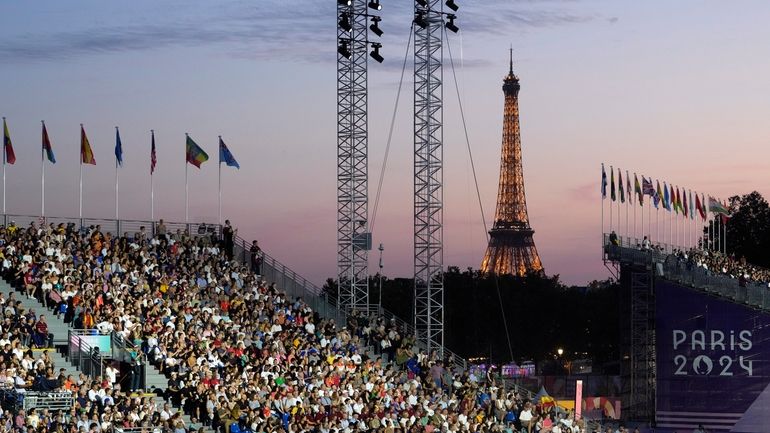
[0,0,770,284]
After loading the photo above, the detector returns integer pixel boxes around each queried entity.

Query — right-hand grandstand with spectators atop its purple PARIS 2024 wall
[604,235,770,433]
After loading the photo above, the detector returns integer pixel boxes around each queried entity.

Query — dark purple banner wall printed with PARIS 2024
[655,280,770,433]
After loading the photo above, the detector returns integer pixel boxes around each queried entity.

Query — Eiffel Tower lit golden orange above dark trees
[481,49,543,276]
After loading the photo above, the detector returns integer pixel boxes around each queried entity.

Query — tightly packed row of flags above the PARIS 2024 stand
[601,164,730,221]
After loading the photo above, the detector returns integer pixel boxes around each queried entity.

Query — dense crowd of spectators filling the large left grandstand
[0,220,582,433]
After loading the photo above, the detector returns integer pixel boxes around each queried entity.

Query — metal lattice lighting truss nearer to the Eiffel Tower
[414,0,444,352]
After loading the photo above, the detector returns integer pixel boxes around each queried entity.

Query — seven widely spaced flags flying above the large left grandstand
[3,117,241,174]
